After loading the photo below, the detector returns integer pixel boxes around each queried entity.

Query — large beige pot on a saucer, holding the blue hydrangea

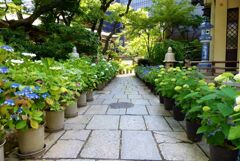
[17,126,44,155]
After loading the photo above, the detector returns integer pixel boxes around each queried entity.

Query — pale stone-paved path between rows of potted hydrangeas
[9,75,208,161]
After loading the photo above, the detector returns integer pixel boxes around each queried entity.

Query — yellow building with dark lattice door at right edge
[204,0,240,68]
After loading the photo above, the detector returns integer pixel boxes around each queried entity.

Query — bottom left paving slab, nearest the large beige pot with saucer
[44,140,84,158]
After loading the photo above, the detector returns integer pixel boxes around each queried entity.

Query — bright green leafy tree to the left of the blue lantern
[149,0,194,40]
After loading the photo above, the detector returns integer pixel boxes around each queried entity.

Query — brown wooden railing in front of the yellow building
[185,61,239,76]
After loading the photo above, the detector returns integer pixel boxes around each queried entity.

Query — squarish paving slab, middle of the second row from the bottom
[120,116,146,130]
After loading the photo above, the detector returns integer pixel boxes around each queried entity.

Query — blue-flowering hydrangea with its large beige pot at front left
[0,82,44,157]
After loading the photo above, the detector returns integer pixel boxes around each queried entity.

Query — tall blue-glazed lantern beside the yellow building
[199,20,213,68]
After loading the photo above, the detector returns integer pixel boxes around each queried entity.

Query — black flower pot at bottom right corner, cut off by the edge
[209,145,239,161]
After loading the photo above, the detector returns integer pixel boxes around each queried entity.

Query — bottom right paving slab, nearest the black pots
[159,143,208,161]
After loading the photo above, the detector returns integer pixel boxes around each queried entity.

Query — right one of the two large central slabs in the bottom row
[121,131,162,160]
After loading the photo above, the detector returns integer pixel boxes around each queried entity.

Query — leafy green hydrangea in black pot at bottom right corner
[198,87,240,161]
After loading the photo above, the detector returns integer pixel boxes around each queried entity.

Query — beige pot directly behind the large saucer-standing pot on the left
[46,110,64,132]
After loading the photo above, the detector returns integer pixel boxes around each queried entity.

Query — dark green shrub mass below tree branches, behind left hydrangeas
[2,24,99,59]
